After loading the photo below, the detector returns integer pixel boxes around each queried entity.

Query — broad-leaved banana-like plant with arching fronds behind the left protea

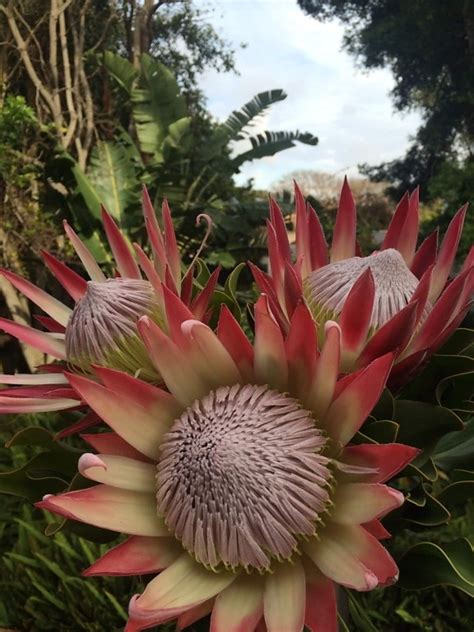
[68,52,318,256]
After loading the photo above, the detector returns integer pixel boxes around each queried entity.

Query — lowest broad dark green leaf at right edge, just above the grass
[399,538,474,597]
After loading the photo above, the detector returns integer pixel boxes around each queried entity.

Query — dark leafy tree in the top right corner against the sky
[298,0,474,254]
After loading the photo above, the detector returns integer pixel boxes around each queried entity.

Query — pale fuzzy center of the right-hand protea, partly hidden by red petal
[304,248,428,328]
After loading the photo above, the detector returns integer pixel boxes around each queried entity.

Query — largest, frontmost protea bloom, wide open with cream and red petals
[38,291,417,632]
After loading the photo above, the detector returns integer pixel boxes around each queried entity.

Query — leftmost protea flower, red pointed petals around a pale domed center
[0,189,219,424]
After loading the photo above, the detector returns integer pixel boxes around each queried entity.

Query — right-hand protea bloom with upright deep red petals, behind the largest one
[252,180,474,383]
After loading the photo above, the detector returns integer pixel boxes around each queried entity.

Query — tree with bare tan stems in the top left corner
[0,0,234,168]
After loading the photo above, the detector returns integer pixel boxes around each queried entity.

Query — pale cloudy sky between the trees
[200,0,420,188]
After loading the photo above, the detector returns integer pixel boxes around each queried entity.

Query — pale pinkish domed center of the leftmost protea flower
[66,278,163,381]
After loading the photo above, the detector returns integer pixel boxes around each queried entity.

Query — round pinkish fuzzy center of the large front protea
[157,385,331,571]
